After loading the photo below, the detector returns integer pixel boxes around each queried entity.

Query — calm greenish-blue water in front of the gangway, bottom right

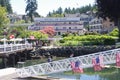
[48,69,120,80]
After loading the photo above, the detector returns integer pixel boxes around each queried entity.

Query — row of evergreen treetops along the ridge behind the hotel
[47,4,97,17]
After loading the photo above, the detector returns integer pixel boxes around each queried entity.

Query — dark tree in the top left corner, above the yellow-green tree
[0,0,13,13]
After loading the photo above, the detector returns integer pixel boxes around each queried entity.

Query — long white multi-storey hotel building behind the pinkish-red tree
[28,17,85,35]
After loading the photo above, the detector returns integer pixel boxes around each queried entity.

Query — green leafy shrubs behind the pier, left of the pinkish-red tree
[8,26,48,39]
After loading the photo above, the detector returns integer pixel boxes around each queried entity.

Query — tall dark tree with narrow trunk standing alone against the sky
[25,0,38,22]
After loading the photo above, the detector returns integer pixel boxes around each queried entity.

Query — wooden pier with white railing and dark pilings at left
[0,43,33,68]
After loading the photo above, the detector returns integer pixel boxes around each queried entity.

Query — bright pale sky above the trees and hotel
[10,0,95,17]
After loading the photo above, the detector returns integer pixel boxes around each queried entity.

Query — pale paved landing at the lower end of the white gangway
[0,68,66,80]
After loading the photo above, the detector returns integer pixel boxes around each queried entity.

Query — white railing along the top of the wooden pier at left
[0,44,32,53]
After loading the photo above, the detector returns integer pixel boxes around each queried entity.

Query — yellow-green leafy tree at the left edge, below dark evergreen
[0,6,10,33]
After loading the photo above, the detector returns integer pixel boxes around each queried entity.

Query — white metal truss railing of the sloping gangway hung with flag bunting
[16,48,120,77]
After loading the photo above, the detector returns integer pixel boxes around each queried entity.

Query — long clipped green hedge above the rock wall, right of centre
[60,35,115,46]
